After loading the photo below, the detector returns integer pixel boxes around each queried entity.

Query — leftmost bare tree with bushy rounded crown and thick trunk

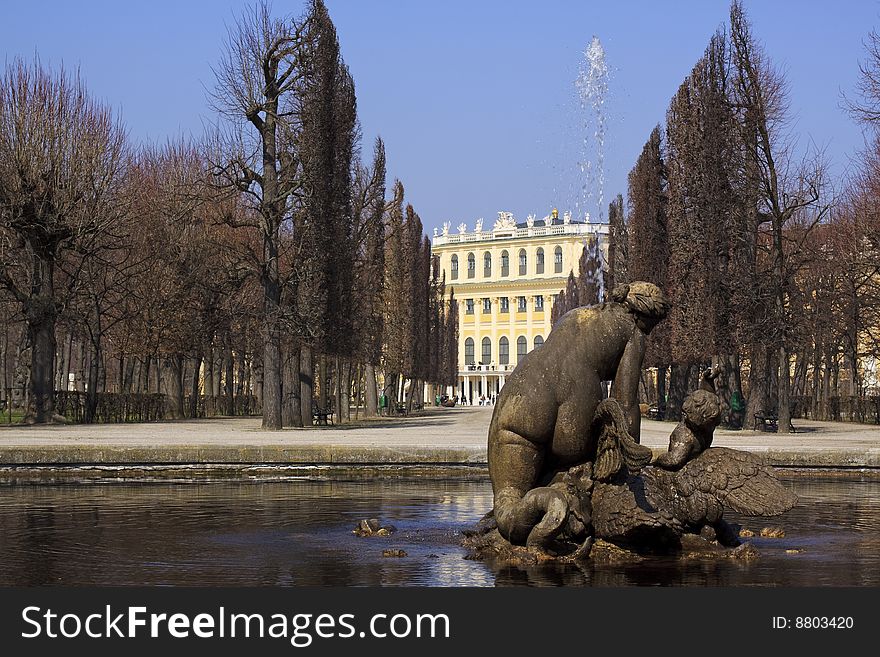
[0,60,125,422]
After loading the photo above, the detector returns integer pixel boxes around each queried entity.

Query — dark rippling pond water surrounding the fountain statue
[0,473,880,586]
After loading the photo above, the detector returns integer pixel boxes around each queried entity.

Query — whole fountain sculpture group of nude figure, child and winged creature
[465,282,796,560]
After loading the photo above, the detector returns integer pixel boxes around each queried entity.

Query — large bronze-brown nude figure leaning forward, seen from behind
[488,282,669,547]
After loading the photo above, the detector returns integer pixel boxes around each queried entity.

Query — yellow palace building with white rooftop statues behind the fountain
[432,209,608,404]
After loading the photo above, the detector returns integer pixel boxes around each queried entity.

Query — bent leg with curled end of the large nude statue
[489,430,568,547]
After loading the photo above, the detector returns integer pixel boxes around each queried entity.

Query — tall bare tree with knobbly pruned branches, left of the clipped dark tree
[213,2,311,429]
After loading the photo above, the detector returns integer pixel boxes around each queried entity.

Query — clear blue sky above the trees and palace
[0,0,880,229]
